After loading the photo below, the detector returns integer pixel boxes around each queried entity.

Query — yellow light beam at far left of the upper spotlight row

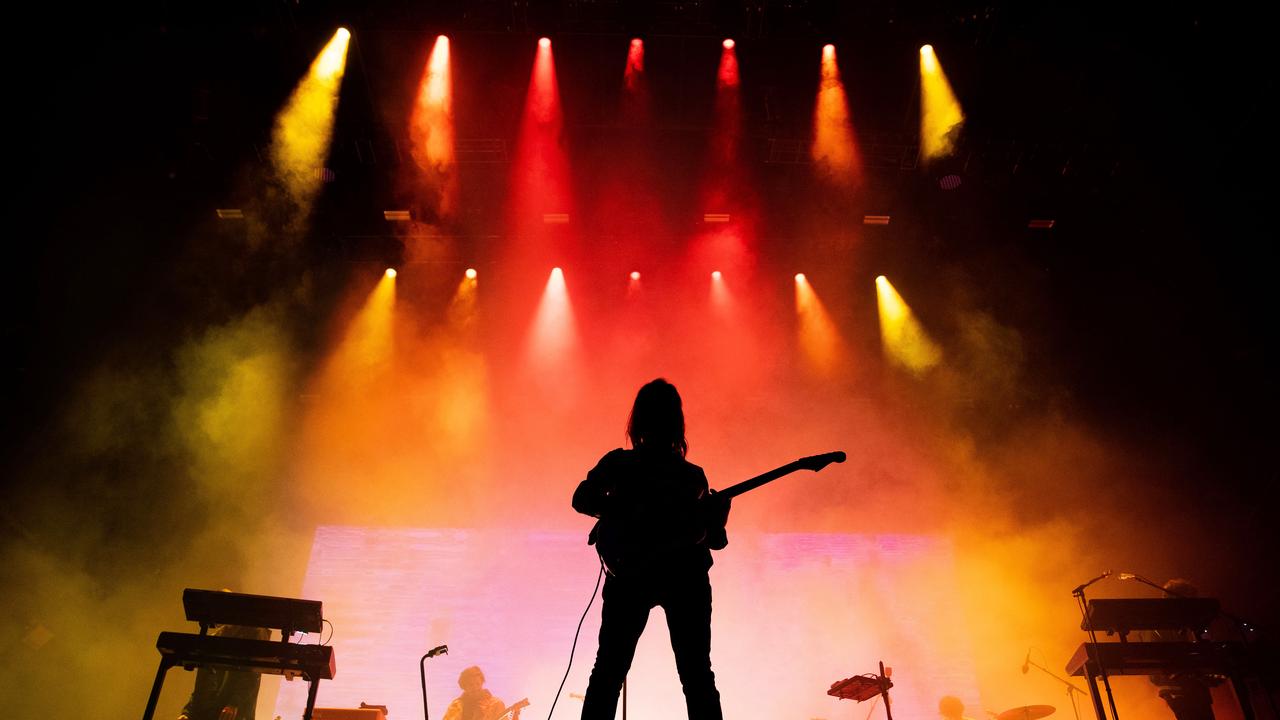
[271,28,351,220]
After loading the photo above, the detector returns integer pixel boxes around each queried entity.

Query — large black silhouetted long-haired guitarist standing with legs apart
[573,378,730,720]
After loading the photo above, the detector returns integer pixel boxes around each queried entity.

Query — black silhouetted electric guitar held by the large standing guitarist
[586,451,845,577]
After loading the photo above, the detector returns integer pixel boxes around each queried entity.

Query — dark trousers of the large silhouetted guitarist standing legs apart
[582,568,722,720]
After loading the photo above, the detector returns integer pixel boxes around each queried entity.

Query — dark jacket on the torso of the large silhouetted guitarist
[573,448,728,573]
